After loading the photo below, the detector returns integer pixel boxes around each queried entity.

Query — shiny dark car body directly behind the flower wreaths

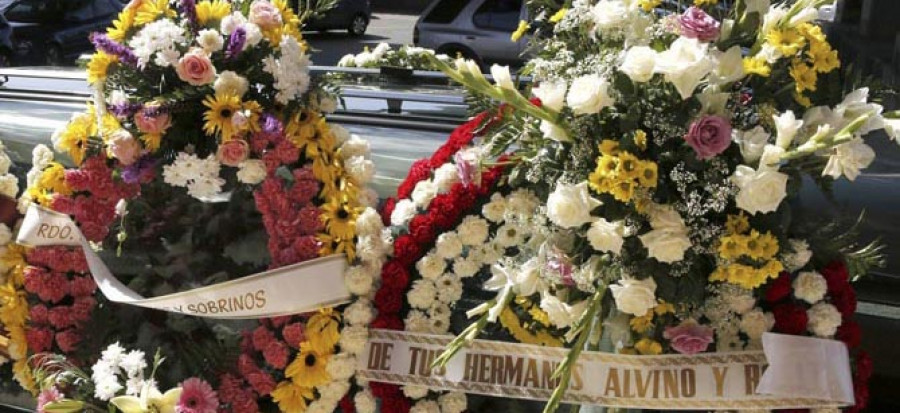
[0,68,900,411]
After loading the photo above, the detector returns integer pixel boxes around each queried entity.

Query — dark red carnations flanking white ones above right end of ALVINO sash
[765,261,872,411]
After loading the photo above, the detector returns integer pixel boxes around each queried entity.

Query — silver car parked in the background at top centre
[413,0,528,65]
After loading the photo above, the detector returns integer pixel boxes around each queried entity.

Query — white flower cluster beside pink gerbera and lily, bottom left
[91,342,155,401]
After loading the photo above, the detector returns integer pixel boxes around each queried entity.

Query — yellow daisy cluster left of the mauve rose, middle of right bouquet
[588,137,658,202]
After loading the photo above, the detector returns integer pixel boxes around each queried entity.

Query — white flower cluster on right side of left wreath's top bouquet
[263,36,310,105]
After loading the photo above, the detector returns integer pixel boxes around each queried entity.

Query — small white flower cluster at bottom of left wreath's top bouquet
[163,152,225,200]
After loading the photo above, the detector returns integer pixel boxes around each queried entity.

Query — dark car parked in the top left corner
[0,0,123,65]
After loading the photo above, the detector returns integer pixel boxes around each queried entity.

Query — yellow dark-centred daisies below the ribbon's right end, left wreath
[272,308,340,412]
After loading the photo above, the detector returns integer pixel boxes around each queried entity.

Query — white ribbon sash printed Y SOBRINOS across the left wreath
[16,205,350,319]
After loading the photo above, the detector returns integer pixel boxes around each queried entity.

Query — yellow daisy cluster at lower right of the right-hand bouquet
[709,214,784,289]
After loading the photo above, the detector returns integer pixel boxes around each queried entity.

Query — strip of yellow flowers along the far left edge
[0,242,36,392]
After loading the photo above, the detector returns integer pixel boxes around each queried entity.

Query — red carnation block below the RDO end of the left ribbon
[25,247,97,356]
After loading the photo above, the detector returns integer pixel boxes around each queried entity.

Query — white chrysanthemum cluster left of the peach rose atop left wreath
[128,19,187,67]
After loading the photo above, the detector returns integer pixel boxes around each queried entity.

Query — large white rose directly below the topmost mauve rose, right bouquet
[656,37,713,99]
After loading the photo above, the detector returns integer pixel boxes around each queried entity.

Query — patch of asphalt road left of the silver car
[303,13,419,66]
